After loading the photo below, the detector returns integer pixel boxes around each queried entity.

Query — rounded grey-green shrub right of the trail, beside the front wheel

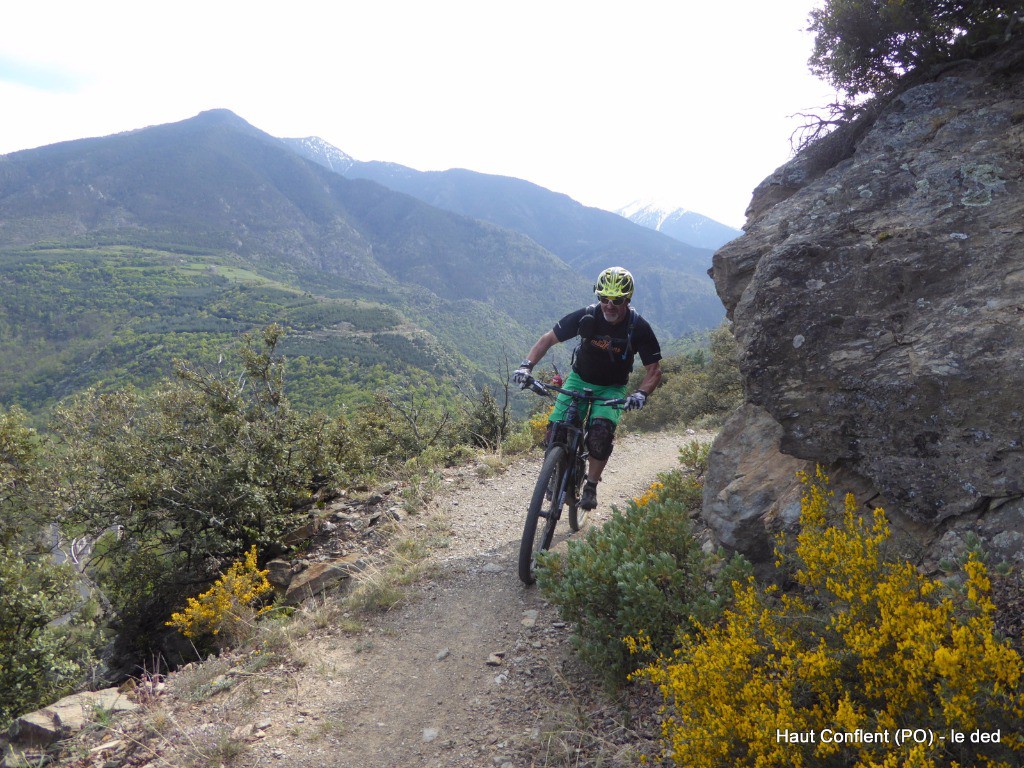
[538,502,749,690]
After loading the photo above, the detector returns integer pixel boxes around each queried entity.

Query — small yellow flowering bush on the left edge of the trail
[166,547,273,644]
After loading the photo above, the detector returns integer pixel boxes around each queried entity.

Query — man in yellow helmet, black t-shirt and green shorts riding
[512,266,662,510]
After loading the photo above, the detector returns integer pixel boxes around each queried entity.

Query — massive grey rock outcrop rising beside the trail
[703,41,1024,573]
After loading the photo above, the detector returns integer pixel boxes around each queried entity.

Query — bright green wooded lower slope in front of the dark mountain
[0,246,471,410]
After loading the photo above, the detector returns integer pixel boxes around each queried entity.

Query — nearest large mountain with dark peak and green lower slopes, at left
[0,111,589,410]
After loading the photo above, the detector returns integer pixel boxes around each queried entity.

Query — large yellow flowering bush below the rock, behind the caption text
[633,470,1024,768]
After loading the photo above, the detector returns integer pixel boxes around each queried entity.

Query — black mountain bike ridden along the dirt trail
[519,377,626,585]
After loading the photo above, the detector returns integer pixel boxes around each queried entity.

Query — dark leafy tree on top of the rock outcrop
[808,0,1024,102]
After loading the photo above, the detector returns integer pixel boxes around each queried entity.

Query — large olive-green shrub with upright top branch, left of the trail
[52,327,354,663]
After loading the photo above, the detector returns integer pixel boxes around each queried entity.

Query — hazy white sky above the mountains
[0,0,836,226]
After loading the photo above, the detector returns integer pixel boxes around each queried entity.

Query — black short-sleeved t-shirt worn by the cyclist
[552,305,662,386]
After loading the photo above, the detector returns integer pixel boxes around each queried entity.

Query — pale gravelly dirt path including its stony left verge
[25,433,709,768]
